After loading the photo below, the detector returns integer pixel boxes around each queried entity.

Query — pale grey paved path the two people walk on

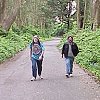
[0,38,100,100]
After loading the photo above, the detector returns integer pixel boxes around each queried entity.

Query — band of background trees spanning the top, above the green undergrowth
[0,0,100,30]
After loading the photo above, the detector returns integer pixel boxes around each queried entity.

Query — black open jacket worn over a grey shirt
[62,42,79,58]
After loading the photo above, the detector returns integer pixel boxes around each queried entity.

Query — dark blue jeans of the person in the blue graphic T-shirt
[32,58,42,78]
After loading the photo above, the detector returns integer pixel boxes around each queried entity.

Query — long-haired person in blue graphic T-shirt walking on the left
[30,35,45,81]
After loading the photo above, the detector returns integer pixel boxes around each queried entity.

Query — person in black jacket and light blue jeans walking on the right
[62,36,79,78]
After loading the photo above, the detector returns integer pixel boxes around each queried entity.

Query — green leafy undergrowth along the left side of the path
[0,26,50,63]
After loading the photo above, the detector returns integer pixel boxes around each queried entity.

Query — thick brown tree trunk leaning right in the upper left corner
[1,0,21,30]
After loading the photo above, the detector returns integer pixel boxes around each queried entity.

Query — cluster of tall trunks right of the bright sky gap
[77,0,100,30]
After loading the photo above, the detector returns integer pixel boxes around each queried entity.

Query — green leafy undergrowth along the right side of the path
[61,29,100,80]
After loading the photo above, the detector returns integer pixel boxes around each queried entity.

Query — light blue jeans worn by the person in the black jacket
[65,57,74,75]
